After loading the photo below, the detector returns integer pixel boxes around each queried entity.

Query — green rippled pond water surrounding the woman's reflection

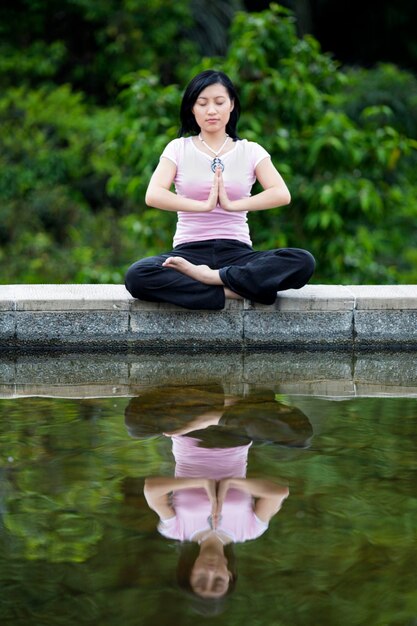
[0,389,417,626]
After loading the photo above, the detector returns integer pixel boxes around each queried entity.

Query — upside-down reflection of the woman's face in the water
[190,554,232,598]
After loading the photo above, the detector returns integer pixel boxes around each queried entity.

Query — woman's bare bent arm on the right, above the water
[219,157,291,211]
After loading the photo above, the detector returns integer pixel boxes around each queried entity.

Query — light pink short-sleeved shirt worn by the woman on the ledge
[161,137,269,246]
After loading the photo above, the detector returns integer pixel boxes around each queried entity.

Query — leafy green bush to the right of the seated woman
[214,6,417,283]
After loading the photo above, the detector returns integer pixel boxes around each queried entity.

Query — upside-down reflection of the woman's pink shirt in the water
[158,436,268,542]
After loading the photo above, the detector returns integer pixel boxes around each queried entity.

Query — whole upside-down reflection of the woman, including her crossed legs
[125,387,312,600]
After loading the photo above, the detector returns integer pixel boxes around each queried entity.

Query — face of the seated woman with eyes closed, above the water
[192,83,233,133]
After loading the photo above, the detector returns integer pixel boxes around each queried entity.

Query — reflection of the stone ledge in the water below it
[0,350,417,399]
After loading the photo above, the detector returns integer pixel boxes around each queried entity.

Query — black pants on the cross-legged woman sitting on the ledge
[125,239,315,310]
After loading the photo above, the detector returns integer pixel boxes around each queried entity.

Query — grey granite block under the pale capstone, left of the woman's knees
[16,311,129,349]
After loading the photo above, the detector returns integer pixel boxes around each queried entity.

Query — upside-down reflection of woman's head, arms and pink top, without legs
[144,435,289,600]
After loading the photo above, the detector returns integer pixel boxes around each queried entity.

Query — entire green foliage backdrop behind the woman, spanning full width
[0,0,417,283]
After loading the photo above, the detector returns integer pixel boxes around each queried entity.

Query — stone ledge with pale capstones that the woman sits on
[0,285,417,350]
